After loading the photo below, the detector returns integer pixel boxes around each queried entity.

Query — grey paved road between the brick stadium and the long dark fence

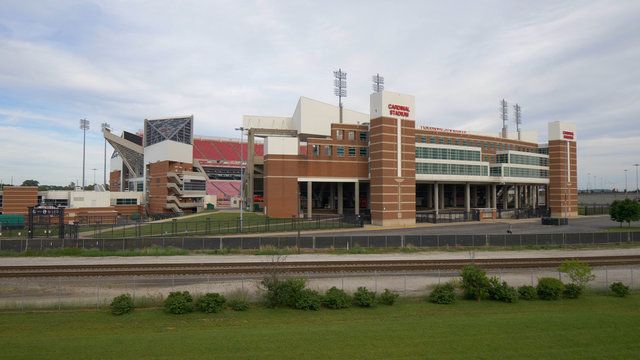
[305,216,640,235]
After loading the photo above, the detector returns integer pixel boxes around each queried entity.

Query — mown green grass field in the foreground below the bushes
[0,294,640,359]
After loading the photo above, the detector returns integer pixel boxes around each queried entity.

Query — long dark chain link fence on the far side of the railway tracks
[0,231,640,252]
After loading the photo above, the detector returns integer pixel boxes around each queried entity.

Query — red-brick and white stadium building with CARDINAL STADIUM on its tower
[0,91,578,226]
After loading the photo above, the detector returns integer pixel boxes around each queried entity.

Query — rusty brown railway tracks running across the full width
[0,255,640,278]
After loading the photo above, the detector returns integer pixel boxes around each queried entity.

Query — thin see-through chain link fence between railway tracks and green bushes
[0,264,640,311]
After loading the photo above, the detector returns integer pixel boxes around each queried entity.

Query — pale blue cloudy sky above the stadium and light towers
[0,0,640,189]
